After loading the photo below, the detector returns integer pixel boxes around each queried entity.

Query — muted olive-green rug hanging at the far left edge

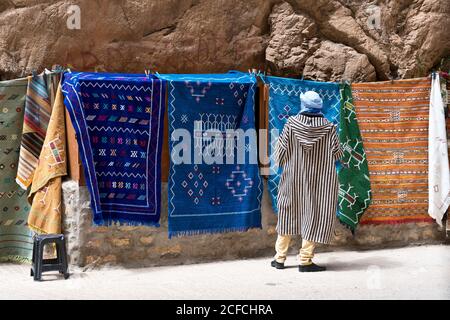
[0,78,33,262]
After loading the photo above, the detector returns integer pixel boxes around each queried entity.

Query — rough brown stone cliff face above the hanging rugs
[0,0,450,81]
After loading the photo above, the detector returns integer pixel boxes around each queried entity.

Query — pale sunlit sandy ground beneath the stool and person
[0,245,450,300]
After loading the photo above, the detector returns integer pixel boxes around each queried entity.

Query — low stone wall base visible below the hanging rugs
[63,181,445,267]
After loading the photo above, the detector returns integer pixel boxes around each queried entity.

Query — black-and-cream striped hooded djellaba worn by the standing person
[275,114,343,244]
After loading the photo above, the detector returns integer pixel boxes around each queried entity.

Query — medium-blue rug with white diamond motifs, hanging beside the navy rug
[160,72,262,237]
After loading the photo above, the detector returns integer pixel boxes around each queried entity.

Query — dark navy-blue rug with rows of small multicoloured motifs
[63,73,166,226]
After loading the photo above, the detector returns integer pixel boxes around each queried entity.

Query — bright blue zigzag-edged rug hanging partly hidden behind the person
[264,77,341,212]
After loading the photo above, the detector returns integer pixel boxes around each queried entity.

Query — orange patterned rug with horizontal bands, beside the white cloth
[352,78,434,224]
